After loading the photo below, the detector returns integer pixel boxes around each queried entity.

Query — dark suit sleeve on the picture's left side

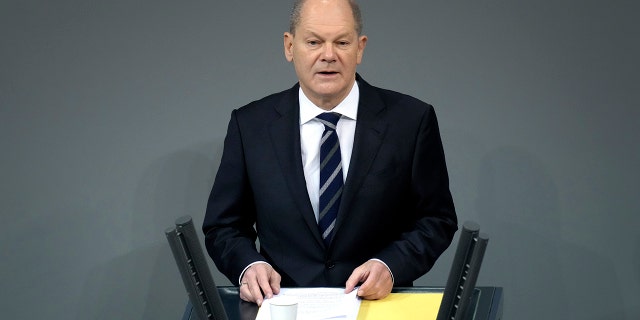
[202,110,266,283]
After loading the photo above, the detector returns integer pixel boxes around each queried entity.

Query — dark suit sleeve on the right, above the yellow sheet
[376,106,458,285]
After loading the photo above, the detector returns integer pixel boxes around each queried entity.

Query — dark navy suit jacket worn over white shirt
[203,75,457,287]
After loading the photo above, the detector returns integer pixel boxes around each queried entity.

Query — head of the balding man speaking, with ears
[284,0,367,110]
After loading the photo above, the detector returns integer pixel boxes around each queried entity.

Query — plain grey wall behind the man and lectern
[0,0,640,319]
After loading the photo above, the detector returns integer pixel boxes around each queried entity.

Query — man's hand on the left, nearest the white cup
[240,263,281,306]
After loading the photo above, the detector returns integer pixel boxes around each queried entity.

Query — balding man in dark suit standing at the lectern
[203,0,457,305]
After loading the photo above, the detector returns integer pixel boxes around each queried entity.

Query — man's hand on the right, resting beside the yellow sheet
[345,260,393,300]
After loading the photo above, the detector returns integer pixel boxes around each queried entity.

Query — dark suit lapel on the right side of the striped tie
[335,76,388,233]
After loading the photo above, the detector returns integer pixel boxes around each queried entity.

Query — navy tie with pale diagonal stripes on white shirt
[316,112,343,247]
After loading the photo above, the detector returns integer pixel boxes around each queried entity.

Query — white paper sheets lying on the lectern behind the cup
[256,288,361,320]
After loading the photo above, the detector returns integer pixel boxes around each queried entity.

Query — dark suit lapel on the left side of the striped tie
[269,85,324,245]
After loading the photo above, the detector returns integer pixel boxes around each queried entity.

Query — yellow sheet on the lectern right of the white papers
[358,292,443,320]
